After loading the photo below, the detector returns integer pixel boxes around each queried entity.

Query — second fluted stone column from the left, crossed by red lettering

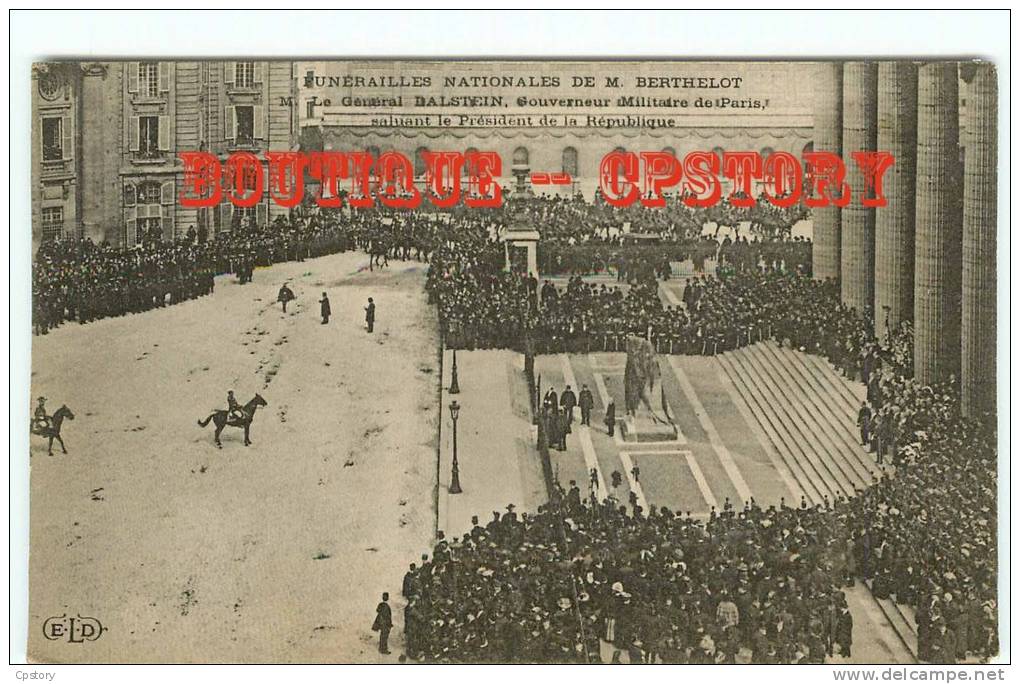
[839,62,878,313]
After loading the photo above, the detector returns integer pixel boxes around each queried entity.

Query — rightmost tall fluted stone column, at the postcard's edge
[960,64,999,416]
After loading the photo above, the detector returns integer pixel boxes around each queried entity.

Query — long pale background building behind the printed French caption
[295,61,813,198]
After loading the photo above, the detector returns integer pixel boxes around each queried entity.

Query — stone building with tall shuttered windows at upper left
[32,61,298,248]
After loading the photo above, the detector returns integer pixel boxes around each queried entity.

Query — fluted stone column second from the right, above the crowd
[914,62,963,384]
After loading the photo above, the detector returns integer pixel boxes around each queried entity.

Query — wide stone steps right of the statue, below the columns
[715,341,917,657]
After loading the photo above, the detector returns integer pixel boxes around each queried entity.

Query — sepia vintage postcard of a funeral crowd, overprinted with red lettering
[21,55,1006,665]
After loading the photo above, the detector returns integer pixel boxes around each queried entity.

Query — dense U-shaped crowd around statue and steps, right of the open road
[405,199,999,663]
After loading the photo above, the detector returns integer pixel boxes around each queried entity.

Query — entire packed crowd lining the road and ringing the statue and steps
[33,191,998,663]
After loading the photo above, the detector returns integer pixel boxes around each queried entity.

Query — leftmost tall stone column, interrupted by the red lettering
[811,62,843,280]
